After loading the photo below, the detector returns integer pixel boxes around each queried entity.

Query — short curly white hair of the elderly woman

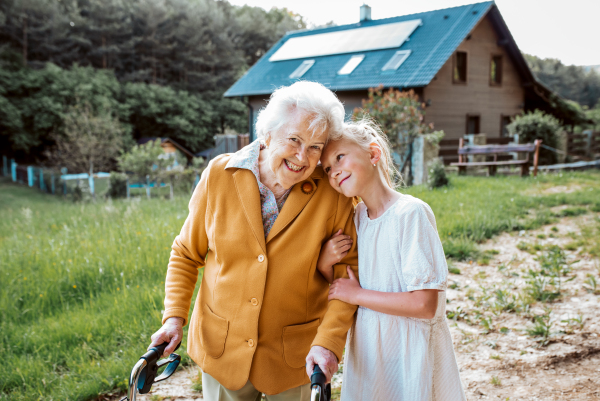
[256,81,344,141]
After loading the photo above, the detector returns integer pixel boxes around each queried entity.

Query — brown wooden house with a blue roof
[225,1,576,157]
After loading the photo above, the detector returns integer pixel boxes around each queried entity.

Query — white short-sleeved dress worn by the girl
[341,195,466,401]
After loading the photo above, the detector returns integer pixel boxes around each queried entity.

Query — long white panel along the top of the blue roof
[269,19,422,61]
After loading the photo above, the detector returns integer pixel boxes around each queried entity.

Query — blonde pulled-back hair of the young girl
[330,116,402,190]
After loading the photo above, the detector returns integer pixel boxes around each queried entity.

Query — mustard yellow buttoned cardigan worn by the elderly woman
[163,155,358,394]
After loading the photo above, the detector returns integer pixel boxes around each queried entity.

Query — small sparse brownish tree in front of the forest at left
[46,102,124,175]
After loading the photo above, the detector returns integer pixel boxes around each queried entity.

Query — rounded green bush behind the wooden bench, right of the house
[506,110,561,164]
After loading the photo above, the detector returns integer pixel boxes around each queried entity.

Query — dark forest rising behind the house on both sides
[0,0,600,165]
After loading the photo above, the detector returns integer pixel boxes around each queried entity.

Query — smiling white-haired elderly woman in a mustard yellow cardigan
[152,82,357,401]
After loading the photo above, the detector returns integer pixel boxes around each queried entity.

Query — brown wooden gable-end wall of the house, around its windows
[423,17,525,139]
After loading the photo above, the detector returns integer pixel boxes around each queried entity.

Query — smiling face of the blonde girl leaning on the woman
[321,140,379,198]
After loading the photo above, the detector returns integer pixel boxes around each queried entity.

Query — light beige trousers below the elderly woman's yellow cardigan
[202,372,310,401]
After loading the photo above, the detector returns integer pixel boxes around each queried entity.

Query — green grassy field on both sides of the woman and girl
[0,172,600,400]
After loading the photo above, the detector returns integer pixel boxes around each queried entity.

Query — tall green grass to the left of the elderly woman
[0,180,202,400]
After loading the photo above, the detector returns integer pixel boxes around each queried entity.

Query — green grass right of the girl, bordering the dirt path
[401,171,600,260]
